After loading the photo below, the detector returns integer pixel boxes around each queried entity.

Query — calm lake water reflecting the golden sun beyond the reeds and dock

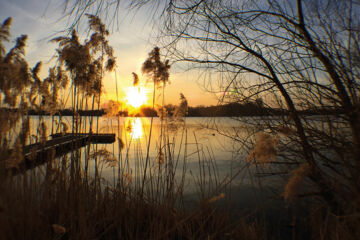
[26,117,334,239]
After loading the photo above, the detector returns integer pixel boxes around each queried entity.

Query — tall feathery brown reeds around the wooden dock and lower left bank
[0,16,265,240]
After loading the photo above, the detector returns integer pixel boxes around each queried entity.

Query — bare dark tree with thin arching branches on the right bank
[137,0,360,219]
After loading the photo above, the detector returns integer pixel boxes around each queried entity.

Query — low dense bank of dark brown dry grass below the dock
[0,115,265,239]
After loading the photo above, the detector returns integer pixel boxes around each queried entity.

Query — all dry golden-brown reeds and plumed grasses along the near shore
[0,16,360,240]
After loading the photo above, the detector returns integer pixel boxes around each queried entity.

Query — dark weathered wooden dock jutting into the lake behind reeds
[14,133,115,174]
